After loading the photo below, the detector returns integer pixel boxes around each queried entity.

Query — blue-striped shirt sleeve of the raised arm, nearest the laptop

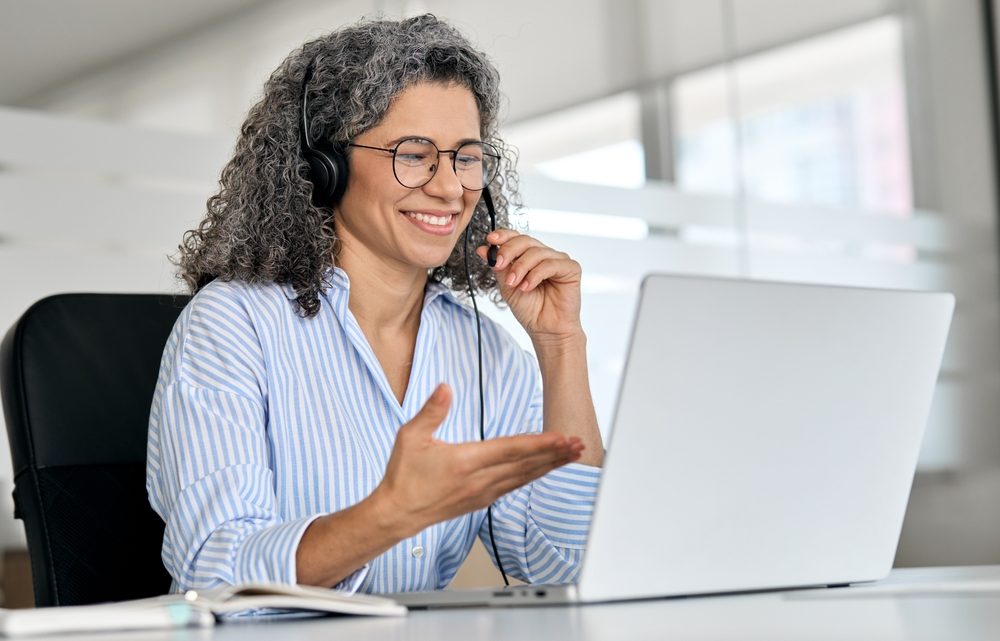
[479,338,601,583]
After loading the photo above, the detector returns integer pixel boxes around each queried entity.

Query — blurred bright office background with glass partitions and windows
[0,0,1000,592]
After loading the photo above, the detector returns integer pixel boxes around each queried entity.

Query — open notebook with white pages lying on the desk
[0,583,406,637]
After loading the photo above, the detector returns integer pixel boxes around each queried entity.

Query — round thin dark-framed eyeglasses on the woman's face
[347,138,500,191]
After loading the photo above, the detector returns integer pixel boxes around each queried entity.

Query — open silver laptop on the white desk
[390,275,955,608]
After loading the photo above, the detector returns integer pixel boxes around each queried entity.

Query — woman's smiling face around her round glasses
[335,82,481,270]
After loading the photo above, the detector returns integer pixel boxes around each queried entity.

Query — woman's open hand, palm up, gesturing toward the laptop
[371,383,583,539]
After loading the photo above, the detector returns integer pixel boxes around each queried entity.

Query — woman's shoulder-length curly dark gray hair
[175,15,521,317]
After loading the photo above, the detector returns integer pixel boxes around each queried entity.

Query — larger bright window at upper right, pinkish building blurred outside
[672,16,913,215]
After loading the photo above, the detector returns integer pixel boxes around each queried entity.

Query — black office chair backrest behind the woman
[0,294,188,606]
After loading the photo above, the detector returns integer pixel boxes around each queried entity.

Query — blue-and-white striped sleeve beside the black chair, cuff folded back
[147,289,367,591]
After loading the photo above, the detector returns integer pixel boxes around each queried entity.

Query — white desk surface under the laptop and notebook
[38,566,1000,641]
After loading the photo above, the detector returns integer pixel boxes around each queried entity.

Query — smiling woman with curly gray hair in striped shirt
[147,15,603,592]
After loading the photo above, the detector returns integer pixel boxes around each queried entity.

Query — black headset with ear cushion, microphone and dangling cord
[299,59,510,586]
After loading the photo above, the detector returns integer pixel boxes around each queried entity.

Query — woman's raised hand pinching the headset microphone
[476,229,583,342]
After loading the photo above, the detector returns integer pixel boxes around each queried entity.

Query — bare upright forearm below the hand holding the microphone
[534,331,604,467]
